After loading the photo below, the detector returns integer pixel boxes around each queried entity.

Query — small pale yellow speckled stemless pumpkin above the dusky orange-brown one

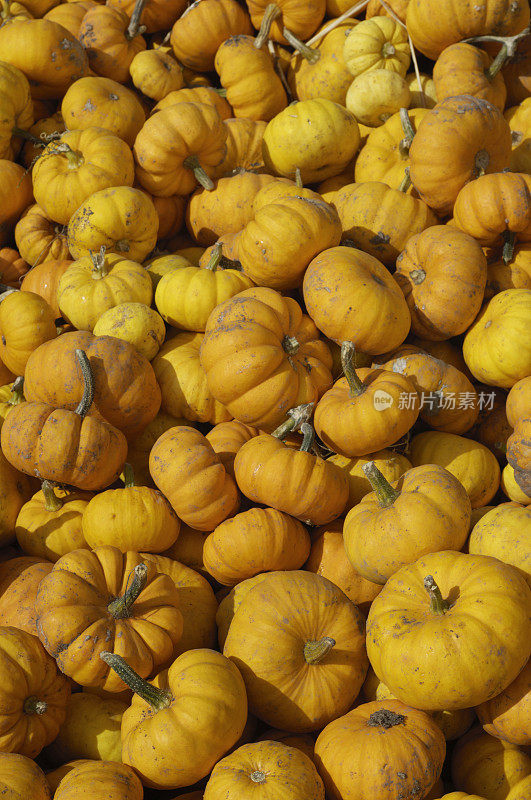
[92,302,166,361]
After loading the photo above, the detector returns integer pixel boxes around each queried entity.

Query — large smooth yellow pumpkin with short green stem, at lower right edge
[367,551,531,710]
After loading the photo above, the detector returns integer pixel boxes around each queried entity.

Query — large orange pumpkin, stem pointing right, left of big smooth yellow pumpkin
[223,570,367,733]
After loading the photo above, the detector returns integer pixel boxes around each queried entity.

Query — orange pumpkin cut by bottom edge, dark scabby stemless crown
[315,700,446,800]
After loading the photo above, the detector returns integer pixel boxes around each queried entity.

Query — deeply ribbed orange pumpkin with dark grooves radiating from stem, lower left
[35,546,183,692]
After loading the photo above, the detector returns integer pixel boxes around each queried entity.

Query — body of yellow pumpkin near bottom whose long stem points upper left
[122,649,247,789]
